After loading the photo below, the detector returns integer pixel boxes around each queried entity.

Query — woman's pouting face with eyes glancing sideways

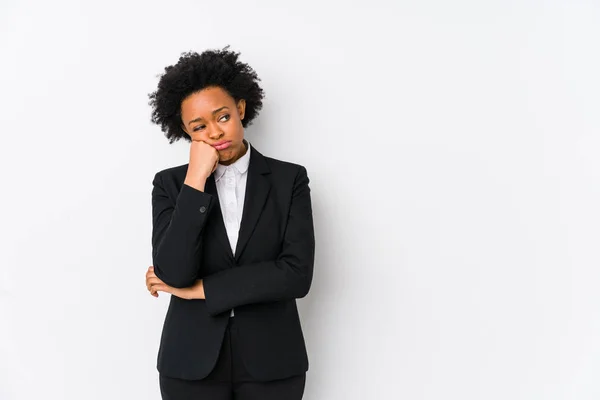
[181,87,247,165]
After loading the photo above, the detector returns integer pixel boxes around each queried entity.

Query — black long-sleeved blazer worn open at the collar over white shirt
[152,146,315,380]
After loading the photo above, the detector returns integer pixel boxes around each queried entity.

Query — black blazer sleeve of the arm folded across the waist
[203,166,315,316]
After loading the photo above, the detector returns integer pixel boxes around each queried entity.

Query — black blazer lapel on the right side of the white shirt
[234,146,271,261]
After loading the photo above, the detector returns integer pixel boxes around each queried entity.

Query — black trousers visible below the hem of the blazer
[159,317,306,400]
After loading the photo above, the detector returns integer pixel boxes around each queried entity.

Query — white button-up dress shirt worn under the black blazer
[215,140,250,317]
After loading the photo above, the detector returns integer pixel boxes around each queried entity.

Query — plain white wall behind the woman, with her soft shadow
[0,0,600,400]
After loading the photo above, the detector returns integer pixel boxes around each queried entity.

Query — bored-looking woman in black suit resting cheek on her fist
[146,47,315,400]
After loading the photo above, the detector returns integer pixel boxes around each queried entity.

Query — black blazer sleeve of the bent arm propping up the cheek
[152,173,213,288]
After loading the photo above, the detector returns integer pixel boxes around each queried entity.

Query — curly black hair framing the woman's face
[148,46,264,143]
